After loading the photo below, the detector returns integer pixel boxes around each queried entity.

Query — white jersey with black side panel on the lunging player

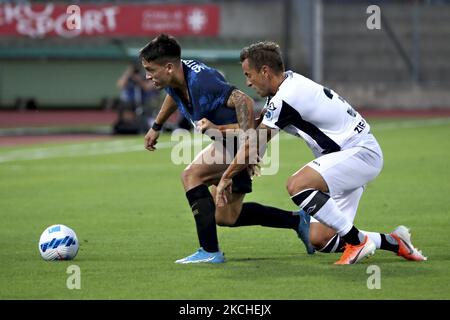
[262,71,370,157]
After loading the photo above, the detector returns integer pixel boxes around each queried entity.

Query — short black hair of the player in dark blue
[139,33,181,64]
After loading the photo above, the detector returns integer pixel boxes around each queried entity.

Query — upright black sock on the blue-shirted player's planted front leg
[186,184,219,252]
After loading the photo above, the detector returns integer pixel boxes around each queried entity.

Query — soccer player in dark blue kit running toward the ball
[140,34,313,264]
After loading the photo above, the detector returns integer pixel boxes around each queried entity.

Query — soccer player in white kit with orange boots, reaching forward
[216,42,426,264]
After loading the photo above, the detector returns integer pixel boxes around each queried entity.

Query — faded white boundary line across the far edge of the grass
[0,118,450,163]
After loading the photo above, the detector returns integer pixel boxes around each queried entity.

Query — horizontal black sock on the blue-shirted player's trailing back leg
[232,202,300,230]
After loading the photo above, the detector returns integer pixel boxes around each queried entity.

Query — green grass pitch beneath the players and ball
[0,119,450,300]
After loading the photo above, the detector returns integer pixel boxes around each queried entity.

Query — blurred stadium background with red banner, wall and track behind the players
[0,0,450,145]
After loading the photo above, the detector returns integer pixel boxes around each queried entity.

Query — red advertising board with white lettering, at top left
[0,3,220,38]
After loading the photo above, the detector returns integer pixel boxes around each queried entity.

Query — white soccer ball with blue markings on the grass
[39,224,79,260]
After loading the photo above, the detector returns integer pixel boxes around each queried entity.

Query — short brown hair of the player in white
[240,41,284,72]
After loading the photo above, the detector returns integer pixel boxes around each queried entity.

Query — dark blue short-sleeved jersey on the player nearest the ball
[165,60,237,125]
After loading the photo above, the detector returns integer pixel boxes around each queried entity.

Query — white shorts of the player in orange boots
[306,134,383,222]
